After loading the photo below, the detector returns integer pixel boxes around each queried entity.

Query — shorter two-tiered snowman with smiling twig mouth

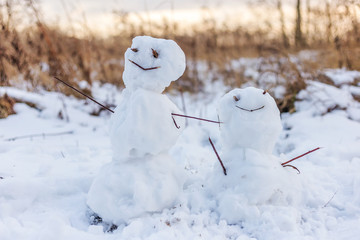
[209,87,297,224]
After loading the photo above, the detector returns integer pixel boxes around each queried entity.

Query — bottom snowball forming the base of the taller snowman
[87,155,184,225]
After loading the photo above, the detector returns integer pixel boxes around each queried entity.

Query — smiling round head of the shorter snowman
[218,87,282,154]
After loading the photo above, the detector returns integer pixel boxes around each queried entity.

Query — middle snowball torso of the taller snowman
[110,89,185,161]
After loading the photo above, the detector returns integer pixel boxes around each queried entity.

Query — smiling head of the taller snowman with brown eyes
[123,36,185,93]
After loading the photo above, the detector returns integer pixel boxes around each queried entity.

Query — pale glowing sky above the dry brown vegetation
[35,0,295,36]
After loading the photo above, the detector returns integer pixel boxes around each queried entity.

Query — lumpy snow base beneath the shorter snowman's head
[208,148,301,224]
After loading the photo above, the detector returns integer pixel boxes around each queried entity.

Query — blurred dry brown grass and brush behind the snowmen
[0,0,360,112]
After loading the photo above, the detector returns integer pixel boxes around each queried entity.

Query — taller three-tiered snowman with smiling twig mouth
[87,36,185,225]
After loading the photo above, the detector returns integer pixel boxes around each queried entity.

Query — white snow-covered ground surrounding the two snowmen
[0,69,360,240]
